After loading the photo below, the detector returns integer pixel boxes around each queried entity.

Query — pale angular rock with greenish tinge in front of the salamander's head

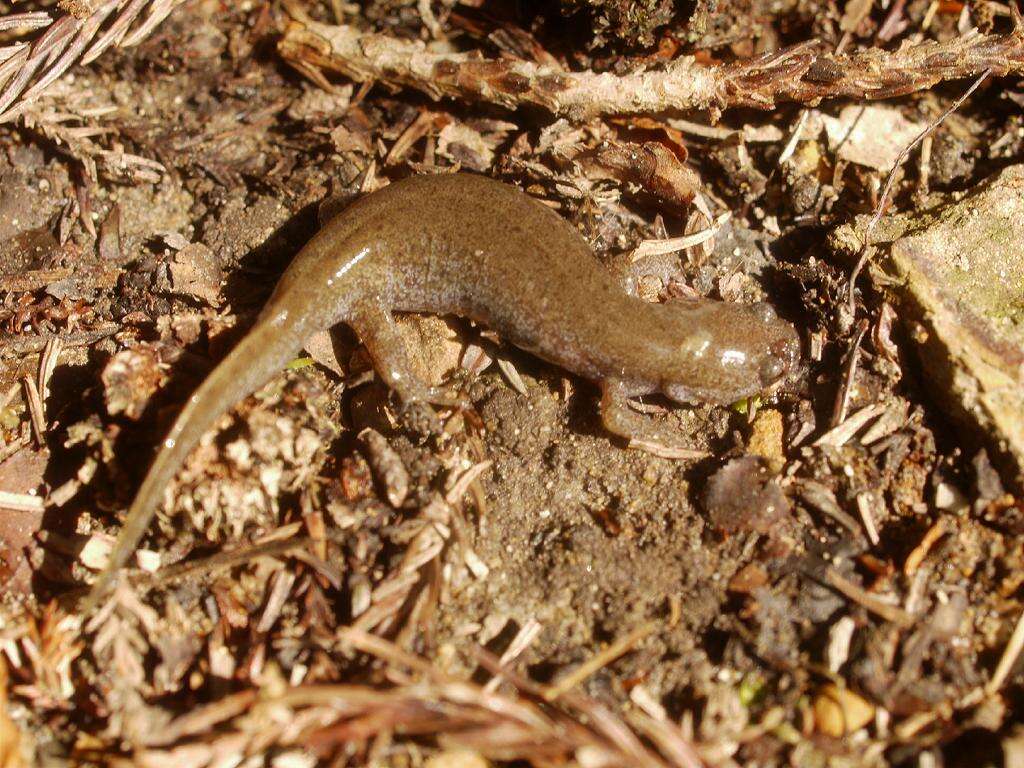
[833,166,1024,488]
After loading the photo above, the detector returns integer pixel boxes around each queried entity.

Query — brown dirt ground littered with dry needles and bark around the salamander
[0,0,1024,768]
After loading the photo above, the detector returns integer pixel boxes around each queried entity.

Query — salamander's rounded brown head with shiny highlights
[660,302,800,403]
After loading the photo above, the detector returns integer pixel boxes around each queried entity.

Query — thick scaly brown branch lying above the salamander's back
[279,20,1024,119]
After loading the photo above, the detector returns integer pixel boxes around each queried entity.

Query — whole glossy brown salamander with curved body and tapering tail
[87,173,799,607]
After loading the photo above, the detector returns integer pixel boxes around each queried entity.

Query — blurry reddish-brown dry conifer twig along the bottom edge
[110,629,700,768]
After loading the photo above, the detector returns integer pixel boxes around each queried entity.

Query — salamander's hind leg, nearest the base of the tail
[351,307,466,415]
